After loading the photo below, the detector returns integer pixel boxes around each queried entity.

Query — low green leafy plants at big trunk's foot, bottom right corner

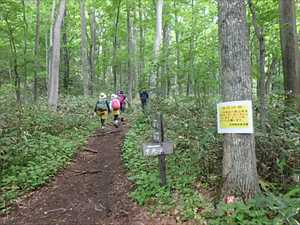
[207,192,300,225]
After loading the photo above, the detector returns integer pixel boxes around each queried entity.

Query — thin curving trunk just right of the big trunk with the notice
[248,0,268,133]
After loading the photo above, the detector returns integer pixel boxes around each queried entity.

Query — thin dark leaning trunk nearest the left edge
[4,17,21,105]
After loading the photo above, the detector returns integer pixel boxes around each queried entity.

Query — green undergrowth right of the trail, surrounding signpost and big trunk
[123,98,300,225]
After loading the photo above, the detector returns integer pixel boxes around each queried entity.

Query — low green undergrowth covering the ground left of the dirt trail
[0,97,98,213]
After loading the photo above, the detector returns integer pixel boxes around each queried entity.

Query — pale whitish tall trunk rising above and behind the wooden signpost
[150,0,163,91]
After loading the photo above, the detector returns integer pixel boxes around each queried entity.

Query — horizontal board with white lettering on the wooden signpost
[143,142,173,156]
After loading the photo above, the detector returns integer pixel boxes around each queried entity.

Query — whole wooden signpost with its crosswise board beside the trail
[143,113,173,186]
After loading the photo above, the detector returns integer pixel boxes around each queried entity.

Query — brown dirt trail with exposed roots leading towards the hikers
[0,124,176,225]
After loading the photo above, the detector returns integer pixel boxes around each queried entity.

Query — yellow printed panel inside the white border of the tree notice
[220,105,249,129]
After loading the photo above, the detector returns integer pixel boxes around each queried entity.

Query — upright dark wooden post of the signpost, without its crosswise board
[159,113,167,186]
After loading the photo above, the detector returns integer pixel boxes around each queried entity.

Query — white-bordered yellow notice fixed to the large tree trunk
[217,101,253,134]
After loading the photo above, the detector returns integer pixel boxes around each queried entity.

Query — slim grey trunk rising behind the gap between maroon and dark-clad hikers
[127,3,134,104]
